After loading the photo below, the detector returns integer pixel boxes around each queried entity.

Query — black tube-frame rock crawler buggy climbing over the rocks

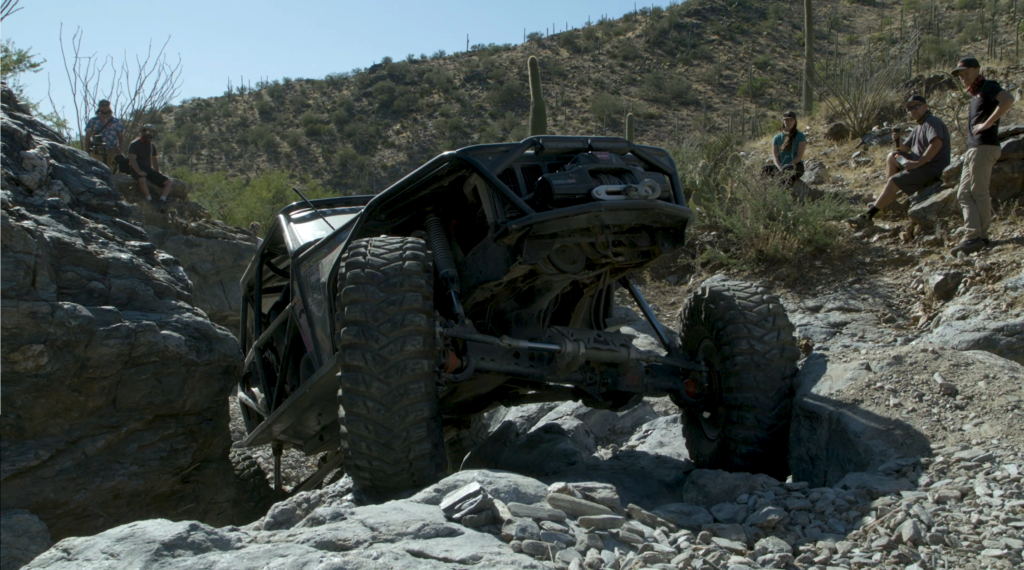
[239,136,799,497]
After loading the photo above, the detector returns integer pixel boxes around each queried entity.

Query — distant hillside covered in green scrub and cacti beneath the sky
[148,0,1019,193]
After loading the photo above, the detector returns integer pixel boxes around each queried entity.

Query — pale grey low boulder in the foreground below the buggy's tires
[26,480,546,570]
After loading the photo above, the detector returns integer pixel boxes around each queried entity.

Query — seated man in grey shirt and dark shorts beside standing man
[847,95,950,228]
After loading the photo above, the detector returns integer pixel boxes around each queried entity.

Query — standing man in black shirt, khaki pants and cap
[951,57,1014,255]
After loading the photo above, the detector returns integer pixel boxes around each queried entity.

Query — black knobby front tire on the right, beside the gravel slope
[680,278,800,480]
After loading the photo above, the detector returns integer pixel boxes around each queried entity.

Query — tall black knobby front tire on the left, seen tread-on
[337,236,446,498]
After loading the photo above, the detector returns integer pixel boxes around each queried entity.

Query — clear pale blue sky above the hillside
[6,0,668,120]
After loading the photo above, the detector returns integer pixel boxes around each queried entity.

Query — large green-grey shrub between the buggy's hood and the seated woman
[674,135,852,269]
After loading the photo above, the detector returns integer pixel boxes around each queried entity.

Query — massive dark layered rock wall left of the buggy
[0,83,256,539]
